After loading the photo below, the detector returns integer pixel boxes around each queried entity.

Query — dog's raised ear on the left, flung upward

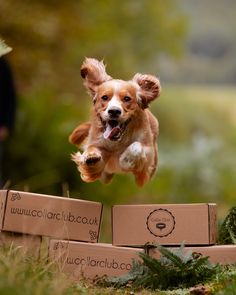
[80,58,112,96]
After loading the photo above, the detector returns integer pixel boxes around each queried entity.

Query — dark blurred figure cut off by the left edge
[0,57,16,187]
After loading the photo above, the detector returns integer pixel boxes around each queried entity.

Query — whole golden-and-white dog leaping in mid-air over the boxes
[69,58,161,186]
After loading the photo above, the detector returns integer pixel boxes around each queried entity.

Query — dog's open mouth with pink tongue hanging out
[103,120,128,141]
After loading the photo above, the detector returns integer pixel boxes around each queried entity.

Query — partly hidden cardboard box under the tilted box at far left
[0,232,41,257]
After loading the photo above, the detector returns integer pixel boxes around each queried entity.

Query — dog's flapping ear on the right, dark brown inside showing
[133,73,161,109]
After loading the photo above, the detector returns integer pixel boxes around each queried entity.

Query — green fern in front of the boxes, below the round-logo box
[100,245,219,290]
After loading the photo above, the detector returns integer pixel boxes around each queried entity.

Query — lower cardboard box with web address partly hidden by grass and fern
[49,240,143,280]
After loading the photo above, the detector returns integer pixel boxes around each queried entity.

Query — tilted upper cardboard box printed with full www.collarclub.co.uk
[0,190,102,242]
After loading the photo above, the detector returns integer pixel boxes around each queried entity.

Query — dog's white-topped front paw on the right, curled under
[120,142,146,171]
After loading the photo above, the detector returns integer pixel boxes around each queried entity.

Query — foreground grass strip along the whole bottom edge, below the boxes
[0,246,236,295]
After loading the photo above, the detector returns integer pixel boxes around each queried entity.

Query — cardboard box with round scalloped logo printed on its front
[112,204,217,246]
